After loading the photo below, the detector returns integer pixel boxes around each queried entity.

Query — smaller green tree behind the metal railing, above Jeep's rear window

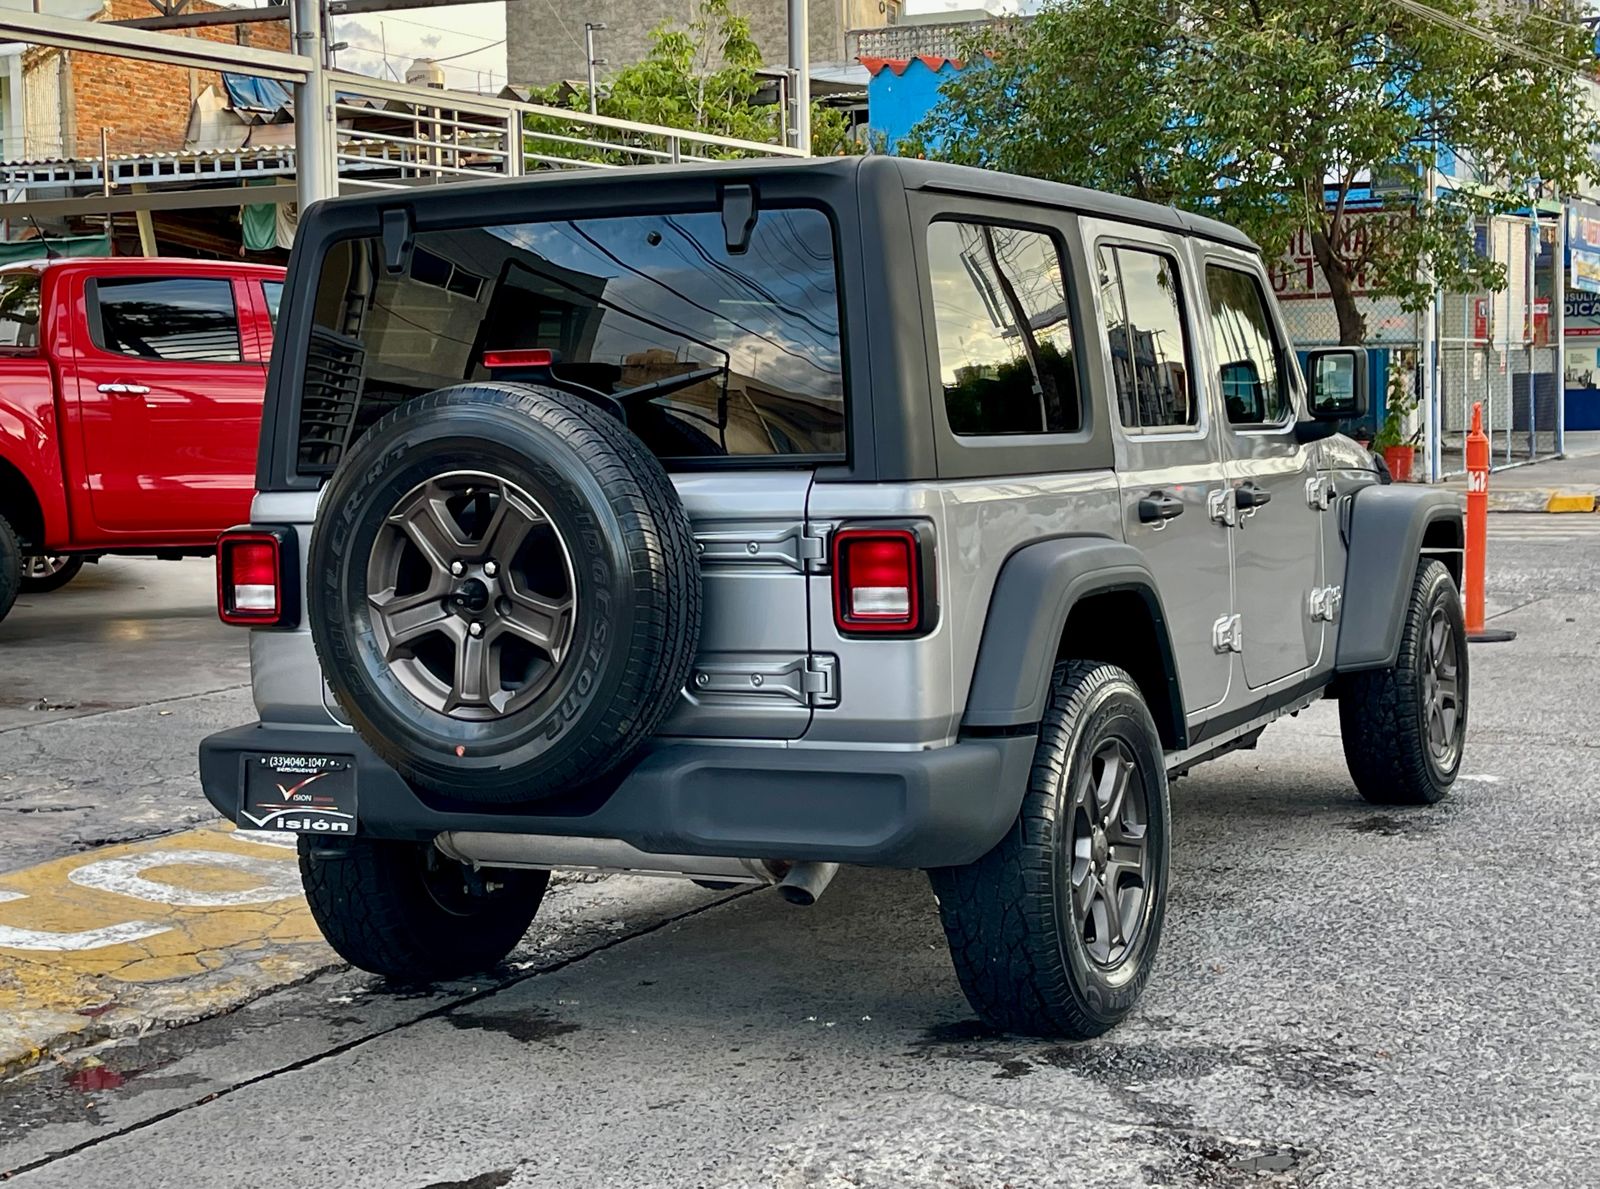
[526,0,861,160]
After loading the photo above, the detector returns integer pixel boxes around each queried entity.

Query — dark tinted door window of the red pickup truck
[93,277,240,363]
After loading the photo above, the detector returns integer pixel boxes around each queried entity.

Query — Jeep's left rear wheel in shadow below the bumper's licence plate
[299,839,550,983]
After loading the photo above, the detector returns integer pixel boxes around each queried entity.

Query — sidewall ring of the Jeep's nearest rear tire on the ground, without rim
[1054,679,1171,1024]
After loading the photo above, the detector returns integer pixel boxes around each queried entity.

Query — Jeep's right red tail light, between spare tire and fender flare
[834,525,934,635]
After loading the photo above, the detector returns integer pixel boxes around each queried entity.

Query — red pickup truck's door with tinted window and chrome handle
[66,275,266,538]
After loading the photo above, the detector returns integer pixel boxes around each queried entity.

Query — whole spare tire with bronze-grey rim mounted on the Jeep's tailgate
[307,384,701,802]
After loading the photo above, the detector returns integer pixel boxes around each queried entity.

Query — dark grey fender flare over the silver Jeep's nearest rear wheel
[962,536,1187,747]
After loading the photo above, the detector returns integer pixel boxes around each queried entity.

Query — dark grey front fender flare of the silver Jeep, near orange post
[1334,483,1462,672]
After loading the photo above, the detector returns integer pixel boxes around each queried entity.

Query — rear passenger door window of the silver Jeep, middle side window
[1099,246,1198,429]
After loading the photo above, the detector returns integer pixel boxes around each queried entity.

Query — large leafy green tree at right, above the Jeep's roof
[901,0,1600,344]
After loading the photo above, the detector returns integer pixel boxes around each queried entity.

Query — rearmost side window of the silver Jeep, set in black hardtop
[928,221,1083,435]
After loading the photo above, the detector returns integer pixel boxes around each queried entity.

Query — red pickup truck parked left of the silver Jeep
[0,258,283,618]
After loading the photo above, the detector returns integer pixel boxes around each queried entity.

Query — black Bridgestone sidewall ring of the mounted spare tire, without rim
[310,394,688,802]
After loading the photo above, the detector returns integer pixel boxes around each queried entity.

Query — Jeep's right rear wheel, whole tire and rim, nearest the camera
[930,661,1170,1039]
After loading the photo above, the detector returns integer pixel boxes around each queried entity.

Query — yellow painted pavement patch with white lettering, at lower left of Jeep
[0,823,338,1074]
